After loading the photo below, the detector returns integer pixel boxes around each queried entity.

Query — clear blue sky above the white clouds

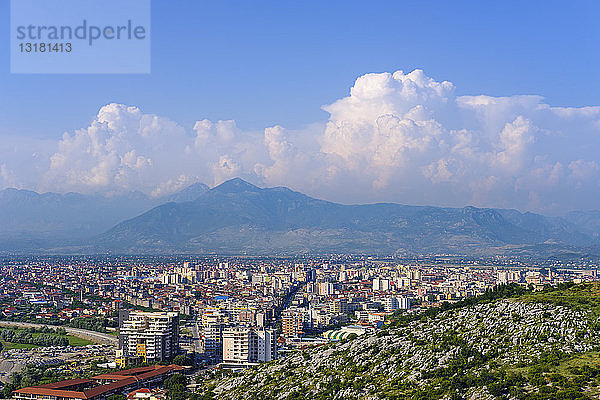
[0,0,600,137]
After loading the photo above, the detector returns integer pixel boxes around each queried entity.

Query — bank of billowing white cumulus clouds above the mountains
[0,70,600,213]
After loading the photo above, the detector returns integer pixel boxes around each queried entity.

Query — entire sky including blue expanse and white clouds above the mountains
[0,0,600,213]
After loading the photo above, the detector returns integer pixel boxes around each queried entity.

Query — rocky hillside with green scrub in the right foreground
[201,283,600,399]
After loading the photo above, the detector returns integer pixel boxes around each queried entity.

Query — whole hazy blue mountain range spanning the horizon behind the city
[0,178,600,255]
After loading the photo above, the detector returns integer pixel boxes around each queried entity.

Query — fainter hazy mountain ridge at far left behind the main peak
[0,184,208,251]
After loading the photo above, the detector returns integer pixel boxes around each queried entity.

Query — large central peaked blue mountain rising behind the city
[94,179,598,254]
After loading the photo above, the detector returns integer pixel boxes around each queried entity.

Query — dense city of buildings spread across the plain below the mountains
[0,255,598,400]
